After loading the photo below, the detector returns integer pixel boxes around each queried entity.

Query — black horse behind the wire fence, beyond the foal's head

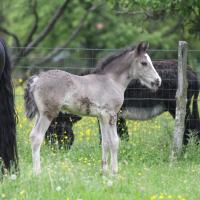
[47,61,200,148]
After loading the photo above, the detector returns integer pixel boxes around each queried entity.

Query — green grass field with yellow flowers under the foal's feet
[0,89,200,200]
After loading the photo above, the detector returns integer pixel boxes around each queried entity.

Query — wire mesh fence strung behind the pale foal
[10,47,200,147]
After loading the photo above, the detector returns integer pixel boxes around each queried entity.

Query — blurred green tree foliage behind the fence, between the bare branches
[0,0,200,71]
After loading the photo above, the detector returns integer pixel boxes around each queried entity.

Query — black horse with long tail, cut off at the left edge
[0,38,18,173]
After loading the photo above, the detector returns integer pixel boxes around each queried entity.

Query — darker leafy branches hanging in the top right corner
[110,0,200,39]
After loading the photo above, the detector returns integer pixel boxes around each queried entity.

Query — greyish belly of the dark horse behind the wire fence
[120,104,166,120]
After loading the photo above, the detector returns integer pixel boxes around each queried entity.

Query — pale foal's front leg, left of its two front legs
[99,118,109,173]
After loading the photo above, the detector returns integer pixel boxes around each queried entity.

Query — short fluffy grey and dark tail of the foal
[24,76,38,119]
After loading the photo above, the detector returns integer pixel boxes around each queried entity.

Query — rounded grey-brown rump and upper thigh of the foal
[32,70,73,118]
